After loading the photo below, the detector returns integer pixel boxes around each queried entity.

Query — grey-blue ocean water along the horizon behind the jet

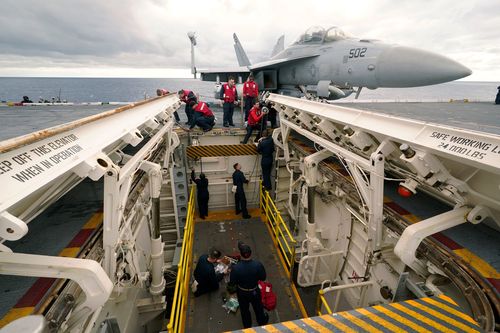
[0,78,500,102]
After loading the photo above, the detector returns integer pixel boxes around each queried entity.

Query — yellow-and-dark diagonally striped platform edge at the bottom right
[229,295,484,333]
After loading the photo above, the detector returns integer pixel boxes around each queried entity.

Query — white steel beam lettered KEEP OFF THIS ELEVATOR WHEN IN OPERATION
[0,94,180,240]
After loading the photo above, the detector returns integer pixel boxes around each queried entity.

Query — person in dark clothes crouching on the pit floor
[193,248,224,297]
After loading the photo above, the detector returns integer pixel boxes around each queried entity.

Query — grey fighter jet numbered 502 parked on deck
[196,26,472,100]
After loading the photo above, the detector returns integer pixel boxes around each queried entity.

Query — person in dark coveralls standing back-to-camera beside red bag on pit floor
[230,242,269,328]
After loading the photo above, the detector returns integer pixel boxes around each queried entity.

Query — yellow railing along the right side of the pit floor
[259,182,297,278]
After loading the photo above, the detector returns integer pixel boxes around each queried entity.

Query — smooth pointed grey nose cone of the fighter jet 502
[375,46,472,88]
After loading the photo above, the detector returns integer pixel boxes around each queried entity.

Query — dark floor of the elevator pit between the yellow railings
[186,212,302,332]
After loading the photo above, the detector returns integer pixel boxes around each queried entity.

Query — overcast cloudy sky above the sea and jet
[0,0,500,81]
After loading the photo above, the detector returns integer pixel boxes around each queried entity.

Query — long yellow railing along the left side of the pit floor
[167,186,195,333]
